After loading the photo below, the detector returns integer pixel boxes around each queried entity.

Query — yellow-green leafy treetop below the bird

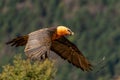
[0,55,56,80]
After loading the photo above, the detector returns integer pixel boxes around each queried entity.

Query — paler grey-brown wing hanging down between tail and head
[25,29,51,60]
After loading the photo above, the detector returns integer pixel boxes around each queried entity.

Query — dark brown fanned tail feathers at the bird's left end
[6,35,28,47]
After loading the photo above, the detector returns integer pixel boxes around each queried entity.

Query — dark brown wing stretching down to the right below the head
[51,37,92,71]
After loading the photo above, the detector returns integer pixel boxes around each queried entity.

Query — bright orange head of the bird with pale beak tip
[57,26,74,36]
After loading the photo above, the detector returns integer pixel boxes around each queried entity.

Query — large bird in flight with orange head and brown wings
[7,26,92,71]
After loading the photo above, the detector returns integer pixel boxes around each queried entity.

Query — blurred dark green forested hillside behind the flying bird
[0,0,120,80]
